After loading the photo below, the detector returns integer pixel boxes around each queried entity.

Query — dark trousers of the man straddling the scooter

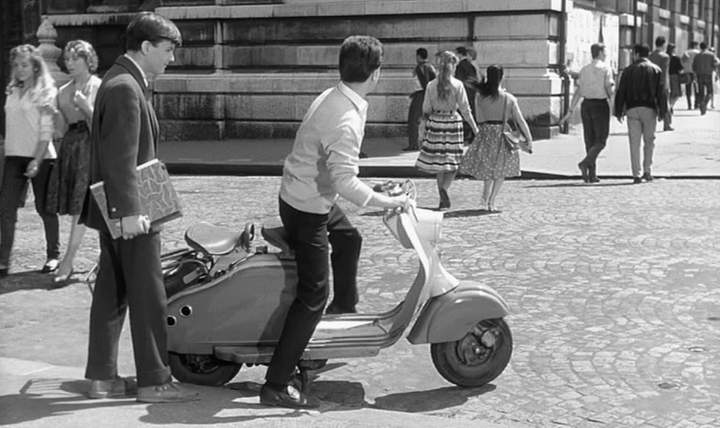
[265,199,362,385]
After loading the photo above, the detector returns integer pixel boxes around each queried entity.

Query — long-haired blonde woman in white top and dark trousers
[0,45,60,277]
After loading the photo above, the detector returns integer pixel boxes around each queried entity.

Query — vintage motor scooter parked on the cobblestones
[163,181,512,389]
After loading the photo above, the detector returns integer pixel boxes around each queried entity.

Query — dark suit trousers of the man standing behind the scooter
[85,232,171,387]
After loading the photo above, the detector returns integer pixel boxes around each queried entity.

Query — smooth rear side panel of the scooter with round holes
[168,254,297,354]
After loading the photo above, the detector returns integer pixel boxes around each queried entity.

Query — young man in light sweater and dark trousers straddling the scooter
[260,36,408,408]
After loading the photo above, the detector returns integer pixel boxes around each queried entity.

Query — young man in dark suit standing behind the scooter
[80,12,197,403]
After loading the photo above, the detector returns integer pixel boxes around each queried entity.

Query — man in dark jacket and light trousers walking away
[615,45,667,184]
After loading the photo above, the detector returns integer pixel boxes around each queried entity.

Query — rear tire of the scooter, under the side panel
[169,352,241,386]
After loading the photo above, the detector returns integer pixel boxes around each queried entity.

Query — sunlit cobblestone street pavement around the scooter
[0,176,720,427]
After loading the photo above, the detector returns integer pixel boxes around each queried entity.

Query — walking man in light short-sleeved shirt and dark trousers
[560,43,615,183]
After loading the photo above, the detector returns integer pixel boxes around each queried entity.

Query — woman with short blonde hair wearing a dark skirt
[47,40,101,284]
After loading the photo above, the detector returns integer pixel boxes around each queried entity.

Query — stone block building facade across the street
[0,0,718,140]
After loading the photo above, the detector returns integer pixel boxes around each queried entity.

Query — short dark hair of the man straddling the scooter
[338,36,383,83]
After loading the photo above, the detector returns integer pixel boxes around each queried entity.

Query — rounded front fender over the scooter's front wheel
[407,281,510,344]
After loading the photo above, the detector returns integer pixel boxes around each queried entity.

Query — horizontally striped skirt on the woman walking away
[415,111,463,174]
